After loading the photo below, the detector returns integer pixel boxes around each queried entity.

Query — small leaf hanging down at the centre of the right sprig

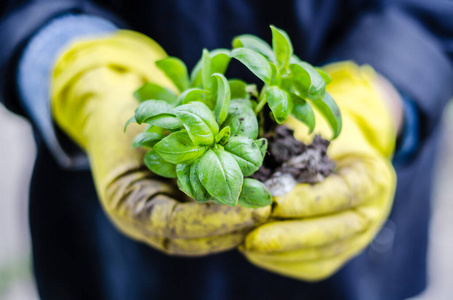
[266,86,294,124]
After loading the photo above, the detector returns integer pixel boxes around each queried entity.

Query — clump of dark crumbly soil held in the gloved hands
[252,125,335,196]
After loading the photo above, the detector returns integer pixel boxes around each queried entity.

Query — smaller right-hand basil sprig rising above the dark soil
[231,26,342,138]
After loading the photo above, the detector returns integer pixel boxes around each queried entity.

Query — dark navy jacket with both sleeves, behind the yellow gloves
[0,0,453,300]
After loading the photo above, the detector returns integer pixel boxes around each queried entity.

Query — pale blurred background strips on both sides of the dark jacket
[0,102,453,300]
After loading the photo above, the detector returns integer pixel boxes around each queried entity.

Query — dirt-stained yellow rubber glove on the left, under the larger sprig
[52,31,270,256]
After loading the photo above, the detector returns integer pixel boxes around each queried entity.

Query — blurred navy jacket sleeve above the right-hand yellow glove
[333,0,453,142]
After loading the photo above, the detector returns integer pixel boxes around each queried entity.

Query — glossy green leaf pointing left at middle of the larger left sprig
[153,130,207,164]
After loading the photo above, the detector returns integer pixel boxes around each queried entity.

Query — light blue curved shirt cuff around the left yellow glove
[17,14,117,169]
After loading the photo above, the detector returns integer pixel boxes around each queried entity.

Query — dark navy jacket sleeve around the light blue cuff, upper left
[0,0,125,116]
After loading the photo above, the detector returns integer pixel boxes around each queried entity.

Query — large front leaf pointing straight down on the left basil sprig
[197,149,243,206]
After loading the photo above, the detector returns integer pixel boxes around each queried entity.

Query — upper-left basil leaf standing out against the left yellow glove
[156,57,189,92]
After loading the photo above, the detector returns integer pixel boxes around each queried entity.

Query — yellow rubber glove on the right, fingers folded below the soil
[240,62,396,281]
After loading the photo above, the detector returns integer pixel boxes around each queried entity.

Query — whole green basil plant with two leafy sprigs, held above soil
[125,26,341,208]
